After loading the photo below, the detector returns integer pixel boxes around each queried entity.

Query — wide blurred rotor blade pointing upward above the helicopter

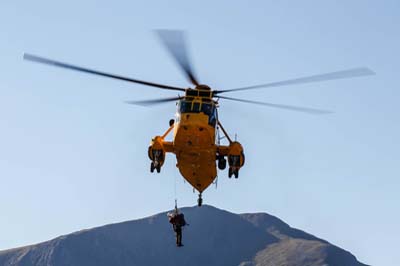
[155,30,199,86]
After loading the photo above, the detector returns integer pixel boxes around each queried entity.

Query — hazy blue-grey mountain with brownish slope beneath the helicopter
[0,205,365,266]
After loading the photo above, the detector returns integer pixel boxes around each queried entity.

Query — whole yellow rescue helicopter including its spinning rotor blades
[24,30,374,206]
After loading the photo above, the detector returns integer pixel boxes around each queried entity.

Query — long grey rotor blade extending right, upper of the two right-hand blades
[214,67,375,94]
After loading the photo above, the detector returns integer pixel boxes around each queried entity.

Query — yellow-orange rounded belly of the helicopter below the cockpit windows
[174,121,217,192]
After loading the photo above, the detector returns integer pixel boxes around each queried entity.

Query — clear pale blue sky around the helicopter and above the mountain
[0,0,400,265]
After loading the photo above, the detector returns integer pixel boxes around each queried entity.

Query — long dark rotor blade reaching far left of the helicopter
[24,54,185,91]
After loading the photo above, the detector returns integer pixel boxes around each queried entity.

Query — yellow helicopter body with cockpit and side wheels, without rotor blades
[149,90,244,193]
